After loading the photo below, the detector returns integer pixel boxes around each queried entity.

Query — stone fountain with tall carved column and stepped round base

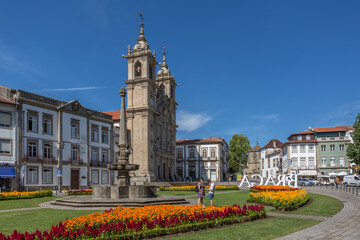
[51,87,189,209]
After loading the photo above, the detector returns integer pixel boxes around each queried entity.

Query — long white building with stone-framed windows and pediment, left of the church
[0,86,116,190]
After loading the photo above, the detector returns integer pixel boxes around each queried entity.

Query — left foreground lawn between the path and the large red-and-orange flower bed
[0,208,95,234]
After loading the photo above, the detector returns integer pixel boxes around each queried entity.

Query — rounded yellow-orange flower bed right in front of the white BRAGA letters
[248,186,309,211]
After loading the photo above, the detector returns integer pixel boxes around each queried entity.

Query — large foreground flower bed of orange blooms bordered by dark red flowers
[0,204,265,240]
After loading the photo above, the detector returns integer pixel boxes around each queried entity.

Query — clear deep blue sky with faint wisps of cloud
[0,0,360,146]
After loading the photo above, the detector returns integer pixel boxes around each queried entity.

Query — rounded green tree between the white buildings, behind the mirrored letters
[229,134,251,173]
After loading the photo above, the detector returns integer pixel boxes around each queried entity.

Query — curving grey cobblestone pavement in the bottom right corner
[276,187,360,240]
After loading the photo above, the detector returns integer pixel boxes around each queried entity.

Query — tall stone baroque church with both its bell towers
[124,23,177,184]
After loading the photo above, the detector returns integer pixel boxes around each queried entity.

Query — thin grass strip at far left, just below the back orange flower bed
[0,197,59,210]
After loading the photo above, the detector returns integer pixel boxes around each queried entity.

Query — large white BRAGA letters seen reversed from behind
[239,174,298,188]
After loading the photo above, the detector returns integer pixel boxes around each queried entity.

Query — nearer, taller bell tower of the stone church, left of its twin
[123,23,157,184]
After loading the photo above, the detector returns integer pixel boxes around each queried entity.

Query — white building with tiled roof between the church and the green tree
[176,137,229,181]
